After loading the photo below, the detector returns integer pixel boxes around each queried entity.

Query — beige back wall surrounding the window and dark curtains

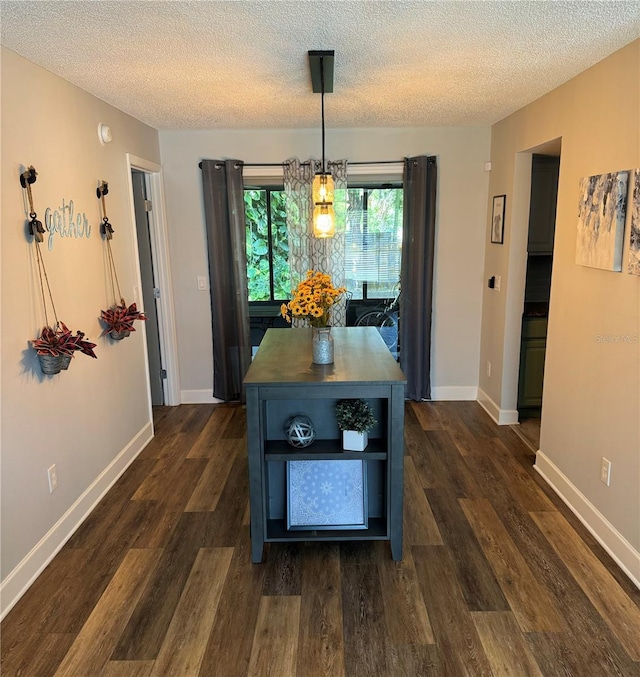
[160,127,489,401]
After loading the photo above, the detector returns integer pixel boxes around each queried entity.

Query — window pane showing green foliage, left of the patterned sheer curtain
[244,188,291,302]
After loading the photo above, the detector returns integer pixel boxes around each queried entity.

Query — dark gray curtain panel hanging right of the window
[400,155,437,401]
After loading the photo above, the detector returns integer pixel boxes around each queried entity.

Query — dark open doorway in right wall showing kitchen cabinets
[517,144,560,426]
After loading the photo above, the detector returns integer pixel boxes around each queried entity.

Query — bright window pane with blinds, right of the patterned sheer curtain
[345,187,403,300]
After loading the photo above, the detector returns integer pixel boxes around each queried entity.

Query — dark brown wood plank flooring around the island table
[0,402,640,677]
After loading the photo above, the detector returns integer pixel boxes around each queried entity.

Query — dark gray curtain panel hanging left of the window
[200,160,251,401]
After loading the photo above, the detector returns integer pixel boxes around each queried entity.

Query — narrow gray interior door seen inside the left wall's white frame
[131,169,164,406]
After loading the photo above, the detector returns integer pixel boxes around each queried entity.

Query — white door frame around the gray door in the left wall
[126,153,180,408]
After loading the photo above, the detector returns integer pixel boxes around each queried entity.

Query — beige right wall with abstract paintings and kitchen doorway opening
[480,41,640,581]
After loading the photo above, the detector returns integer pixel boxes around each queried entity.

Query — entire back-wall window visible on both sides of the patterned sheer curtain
[244,178,403,358]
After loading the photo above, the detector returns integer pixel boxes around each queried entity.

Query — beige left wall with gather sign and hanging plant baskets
[0,49,160,609]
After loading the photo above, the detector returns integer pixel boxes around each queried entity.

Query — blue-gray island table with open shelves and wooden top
[244,327,406,563]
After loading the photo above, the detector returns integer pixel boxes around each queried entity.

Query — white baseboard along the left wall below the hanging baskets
[0,421,153,619]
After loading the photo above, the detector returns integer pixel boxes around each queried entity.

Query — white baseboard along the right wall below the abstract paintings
[533,451,640,588]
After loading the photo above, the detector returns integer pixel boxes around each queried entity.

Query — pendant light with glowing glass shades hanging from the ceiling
[309,50,336,238]
